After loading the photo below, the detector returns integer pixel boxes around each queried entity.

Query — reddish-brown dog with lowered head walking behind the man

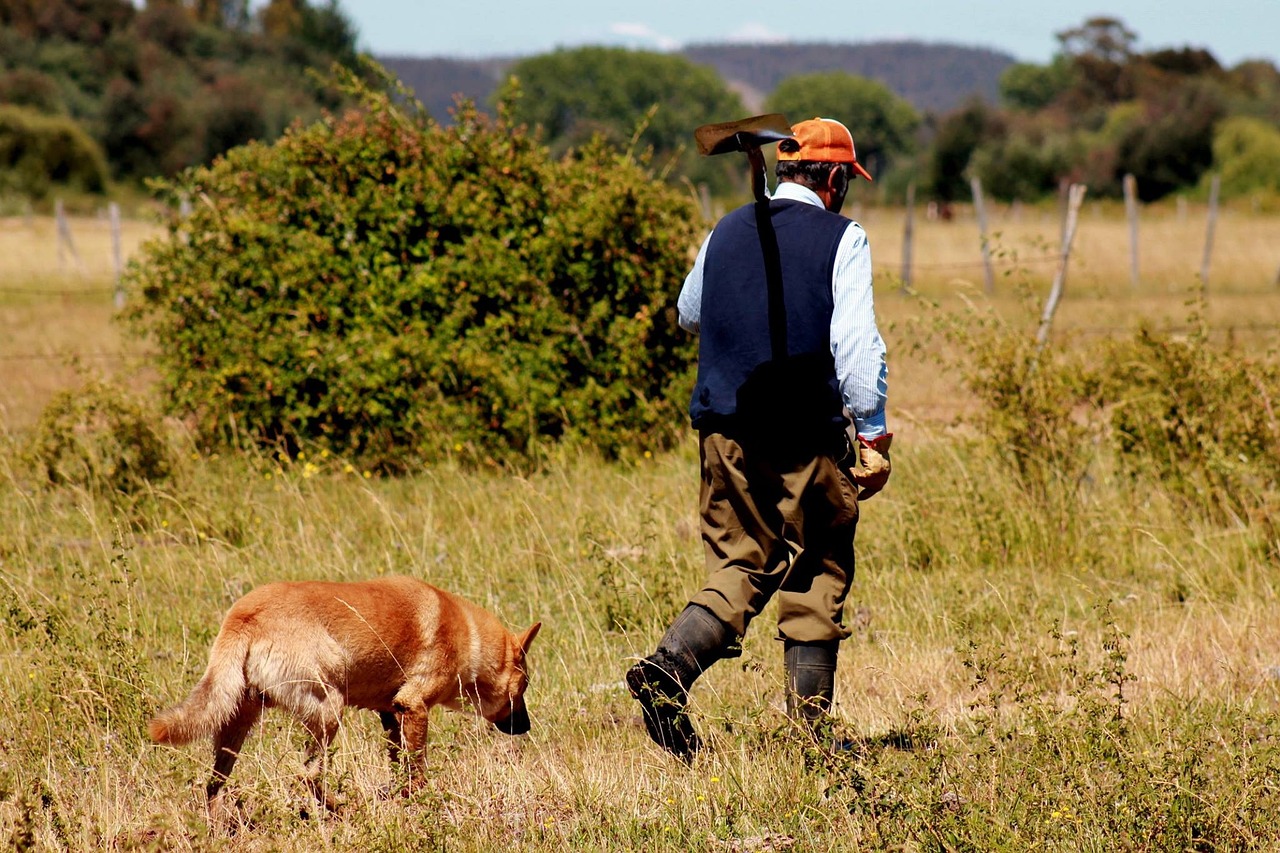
[150,578,541,806]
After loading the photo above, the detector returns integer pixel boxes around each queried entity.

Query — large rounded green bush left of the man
[127,64,696,471]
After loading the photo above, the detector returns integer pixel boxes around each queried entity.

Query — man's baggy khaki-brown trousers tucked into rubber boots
[691,433,858,643]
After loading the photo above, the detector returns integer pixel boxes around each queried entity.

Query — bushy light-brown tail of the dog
[147,625,250,745]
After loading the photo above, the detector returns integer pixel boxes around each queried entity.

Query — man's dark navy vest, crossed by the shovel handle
[689,201,850,432]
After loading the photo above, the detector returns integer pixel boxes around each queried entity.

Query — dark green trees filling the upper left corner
[0,0,356,179]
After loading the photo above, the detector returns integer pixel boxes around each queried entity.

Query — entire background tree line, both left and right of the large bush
[0,6,1280,202]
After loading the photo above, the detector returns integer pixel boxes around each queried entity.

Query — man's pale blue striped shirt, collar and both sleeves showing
[676,181,888,439]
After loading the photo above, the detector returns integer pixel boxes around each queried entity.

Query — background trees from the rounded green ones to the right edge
[493,18,1280,202]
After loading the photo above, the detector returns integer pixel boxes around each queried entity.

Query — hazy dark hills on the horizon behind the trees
[378,41,1015,120]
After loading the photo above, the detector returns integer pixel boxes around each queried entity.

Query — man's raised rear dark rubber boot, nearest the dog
[627,605,736,763]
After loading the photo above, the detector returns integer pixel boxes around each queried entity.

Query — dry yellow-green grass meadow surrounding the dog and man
[0,205,1280,852]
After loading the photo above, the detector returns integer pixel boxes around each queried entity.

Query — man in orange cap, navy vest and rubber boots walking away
[626,118,892,761]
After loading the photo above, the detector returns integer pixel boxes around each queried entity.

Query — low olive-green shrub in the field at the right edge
[1100,329,1280,519]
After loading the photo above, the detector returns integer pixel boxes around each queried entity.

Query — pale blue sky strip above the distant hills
[338,0,1280,67]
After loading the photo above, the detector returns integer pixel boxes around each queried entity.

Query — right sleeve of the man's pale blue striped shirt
[831,223,888,438]
